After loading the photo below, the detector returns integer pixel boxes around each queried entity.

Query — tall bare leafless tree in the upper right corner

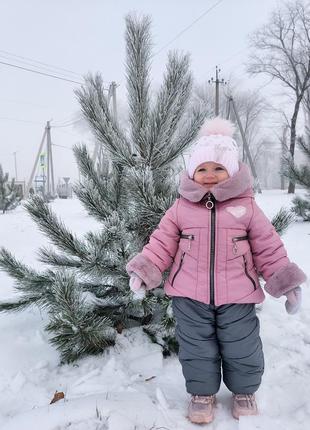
[248,0,310,193]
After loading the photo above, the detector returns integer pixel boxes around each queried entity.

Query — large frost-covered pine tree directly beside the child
[0,16,205,362]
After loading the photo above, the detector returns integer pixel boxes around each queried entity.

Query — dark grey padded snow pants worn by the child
[172,297,264,395]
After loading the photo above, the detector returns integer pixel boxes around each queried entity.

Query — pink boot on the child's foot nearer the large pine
[188,395,215,424]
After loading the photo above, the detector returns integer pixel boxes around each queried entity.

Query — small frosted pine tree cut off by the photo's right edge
[284,129,310,221]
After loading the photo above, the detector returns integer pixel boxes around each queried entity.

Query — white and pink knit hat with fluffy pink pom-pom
[187,117,239,178]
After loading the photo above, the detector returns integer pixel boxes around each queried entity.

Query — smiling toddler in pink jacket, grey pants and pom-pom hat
[126,118,306,423]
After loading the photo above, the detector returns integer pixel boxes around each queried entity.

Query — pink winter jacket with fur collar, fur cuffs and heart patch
[126,163,306,306]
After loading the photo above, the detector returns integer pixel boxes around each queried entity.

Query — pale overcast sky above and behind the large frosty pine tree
[0,0,279,182]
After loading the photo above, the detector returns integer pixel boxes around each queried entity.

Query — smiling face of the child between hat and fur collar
[193,161,229,190]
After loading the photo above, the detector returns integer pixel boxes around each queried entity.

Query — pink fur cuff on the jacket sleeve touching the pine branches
[126,253,162,290]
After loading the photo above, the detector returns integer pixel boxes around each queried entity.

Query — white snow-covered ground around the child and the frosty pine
[0,190,310,430]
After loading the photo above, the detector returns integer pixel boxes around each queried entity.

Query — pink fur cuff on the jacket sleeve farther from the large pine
[265,263,307,298]
